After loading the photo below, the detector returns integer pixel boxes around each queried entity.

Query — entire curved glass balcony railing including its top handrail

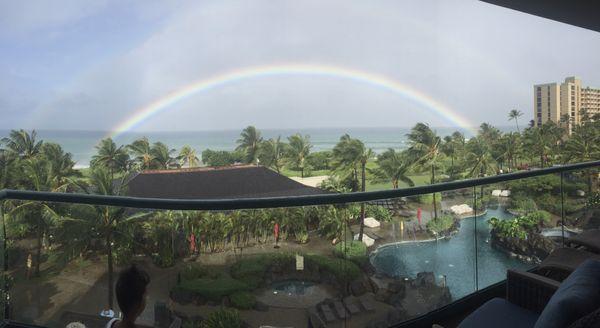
[0,161,600,327]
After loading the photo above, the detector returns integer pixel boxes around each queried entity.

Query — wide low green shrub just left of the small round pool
[174,277,250,302]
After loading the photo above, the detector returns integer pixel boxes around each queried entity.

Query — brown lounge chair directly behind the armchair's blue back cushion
[535,247,600,281]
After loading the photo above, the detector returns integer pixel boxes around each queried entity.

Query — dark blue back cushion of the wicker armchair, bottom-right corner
[535,260,600,328]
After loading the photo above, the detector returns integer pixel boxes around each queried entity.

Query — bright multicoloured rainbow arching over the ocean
[109,64,476,138]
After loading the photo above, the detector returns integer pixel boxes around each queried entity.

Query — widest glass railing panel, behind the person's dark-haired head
[7,203,370,327]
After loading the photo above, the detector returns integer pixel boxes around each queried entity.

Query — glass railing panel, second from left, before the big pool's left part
[366,193,475,321]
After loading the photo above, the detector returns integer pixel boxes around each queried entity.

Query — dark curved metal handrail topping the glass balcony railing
[0,160,600,210]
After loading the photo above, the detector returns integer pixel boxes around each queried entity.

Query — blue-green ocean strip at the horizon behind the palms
[0,126,513,167]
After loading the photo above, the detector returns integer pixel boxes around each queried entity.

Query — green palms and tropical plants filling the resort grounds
[0,110,600,326]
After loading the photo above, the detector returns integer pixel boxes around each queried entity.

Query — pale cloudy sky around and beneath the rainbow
[0,0,600,131]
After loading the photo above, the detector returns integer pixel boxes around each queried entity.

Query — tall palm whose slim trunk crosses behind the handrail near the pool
[407,123,441,220]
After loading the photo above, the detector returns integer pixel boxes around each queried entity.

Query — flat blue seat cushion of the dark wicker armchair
[458,298,538,328]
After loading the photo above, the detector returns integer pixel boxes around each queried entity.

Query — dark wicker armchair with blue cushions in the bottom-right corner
[458,260,600,328]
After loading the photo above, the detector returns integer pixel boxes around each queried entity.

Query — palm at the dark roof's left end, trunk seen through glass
[75,166,149,309]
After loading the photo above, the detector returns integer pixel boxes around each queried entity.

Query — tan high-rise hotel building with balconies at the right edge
[533,77,600,133]
